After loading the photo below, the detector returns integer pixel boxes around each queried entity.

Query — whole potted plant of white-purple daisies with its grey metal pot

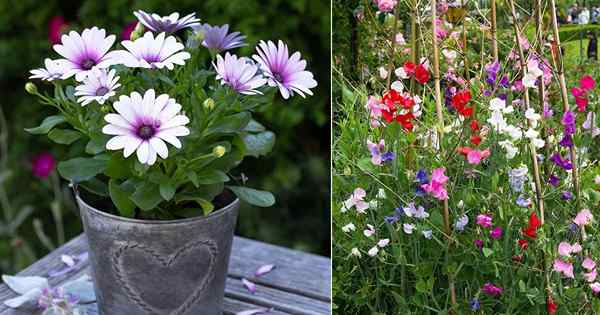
[26,10,317,315]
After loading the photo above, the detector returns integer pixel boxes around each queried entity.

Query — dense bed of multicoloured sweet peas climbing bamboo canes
[333,0,600,314]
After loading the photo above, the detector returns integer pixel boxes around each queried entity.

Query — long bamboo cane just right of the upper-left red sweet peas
[431,0,456,306]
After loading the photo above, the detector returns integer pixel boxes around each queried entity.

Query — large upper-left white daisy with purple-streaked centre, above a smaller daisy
[53,26,118,81]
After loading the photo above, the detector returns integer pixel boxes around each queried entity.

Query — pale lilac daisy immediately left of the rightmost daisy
[213,53,267,95]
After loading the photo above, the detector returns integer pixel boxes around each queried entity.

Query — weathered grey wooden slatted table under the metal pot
[0,235,331,315]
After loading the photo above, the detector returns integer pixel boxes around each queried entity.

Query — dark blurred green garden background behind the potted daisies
[0,0,330,273]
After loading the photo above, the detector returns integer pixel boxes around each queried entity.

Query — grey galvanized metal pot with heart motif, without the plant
[76,194,239,315]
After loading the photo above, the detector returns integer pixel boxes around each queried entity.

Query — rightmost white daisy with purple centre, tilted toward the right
[253,41,317,99]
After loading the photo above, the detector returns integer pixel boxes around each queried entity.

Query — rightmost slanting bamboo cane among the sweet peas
[550,0,585,215]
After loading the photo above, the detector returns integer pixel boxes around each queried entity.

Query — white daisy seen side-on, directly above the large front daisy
[116,32,191,70]
